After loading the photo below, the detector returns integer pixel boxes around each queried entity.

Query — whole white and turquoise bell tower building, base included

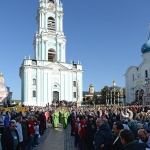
[19,0,83,106]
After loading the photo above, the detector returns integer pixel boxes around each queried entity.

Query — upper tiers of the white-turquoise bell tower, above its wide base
[33,0,66,62]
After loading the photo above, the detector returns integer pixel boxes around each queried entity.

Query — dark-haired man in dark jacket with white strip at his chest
[101,122,124,150]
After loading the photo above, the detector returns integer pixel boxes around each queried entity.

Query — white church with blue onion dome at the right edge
[125,24,150,103]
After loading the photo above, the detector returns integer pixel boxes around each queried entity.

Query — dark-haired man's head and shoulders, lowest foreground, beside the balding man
[119,129,149,150]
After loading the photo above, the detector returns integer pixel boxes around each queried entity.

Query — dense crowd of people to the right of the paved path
[71,105,150,150]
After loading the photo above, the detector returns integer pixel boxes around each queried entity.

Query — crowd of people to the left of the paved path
[0,107,54,150]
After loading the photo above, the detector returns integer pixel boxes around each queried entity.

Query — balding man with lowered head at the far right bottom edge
[138,129,150,147]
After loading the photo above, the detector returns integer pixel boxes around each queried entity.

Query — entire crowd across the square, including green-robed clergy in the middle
[0,105,150,150]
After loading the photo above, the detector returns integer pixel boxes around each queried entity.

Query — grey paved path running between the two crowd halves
[33,124,77,150]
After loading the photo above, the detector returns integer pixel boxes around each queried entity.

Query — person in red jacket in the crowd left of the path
[28,116,35,150]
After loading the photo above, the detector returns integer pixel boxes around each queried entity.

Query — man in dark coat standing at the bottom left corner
[1,121,19,150]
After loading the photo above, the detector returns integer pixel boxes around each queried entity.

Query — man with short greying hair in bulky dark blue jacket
[94,118,111,150]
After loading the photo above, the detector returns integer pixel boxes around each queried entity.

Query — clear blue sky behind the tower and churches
[0,0,150,100]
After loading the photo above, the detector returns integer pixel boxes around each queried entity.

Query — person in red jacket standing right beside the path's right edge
[73,117,79,147]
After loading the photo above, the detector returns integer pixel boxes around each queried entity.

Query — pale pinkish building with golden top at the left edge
[0,73,12,105]
